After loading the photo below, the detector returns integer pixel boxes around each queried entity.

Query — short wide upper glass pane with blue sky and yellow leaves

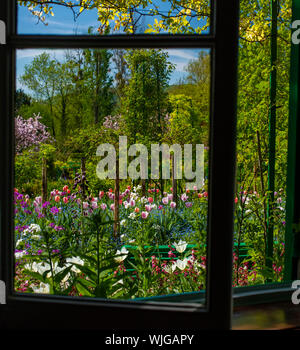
[18,0,210,35]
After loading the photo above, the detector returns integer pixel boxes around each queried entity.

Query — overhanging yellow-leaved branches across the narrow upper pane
[18,0,210,34]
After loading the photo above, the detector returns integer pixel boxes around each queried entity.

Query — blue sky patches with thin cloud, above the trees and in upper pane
[17,6,209,93]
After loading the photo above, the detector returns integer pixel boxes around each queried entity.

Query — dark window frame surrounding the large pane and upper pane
[0,0,243,330]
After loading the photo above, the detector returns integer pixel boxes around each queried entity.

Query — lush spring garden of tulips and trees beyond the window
[14,1,291,299]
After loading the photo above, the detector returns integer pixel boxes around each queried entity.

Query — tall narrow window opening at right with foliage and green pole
[233,2,291,286]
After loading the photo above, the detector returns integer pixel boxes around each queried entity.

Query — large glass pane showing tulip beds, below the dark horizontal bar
[15,49,210,301]
